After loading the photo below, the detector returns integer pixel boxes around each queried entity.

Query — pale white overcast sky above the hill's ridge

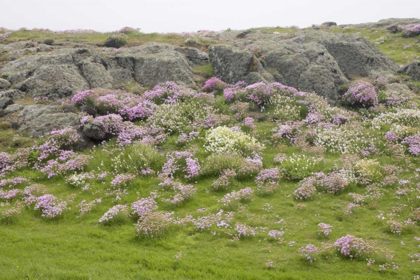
[0,0,420,32]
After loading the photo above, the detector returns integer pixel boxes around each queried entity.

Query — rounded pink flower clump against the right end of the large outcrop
[342,82,378,108]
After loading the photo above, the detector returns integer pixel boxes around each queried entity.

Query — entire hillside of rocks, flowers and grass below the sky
[0,19,420,279]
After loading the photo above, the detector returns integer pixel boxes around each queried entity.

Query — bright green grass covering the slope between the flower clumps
[0,26,420,279]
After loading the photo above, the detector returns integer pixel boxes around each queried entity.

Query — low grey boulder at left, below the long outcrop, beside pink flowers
[18,105,80,137]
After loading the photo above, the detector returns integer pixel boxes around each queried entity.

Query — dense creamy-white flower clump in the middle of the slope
[204,126,264,155]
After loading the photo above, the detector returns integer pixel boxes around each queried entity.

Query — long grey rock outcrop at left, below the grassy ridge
[0,43,200,98]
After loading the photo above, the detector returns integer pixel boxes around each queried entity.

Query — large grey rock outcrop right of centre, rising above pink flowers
[209,30,398,104]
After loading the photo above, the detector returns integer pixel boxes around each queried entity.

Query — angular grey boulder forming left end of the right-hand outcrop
[209,45,273,84]
